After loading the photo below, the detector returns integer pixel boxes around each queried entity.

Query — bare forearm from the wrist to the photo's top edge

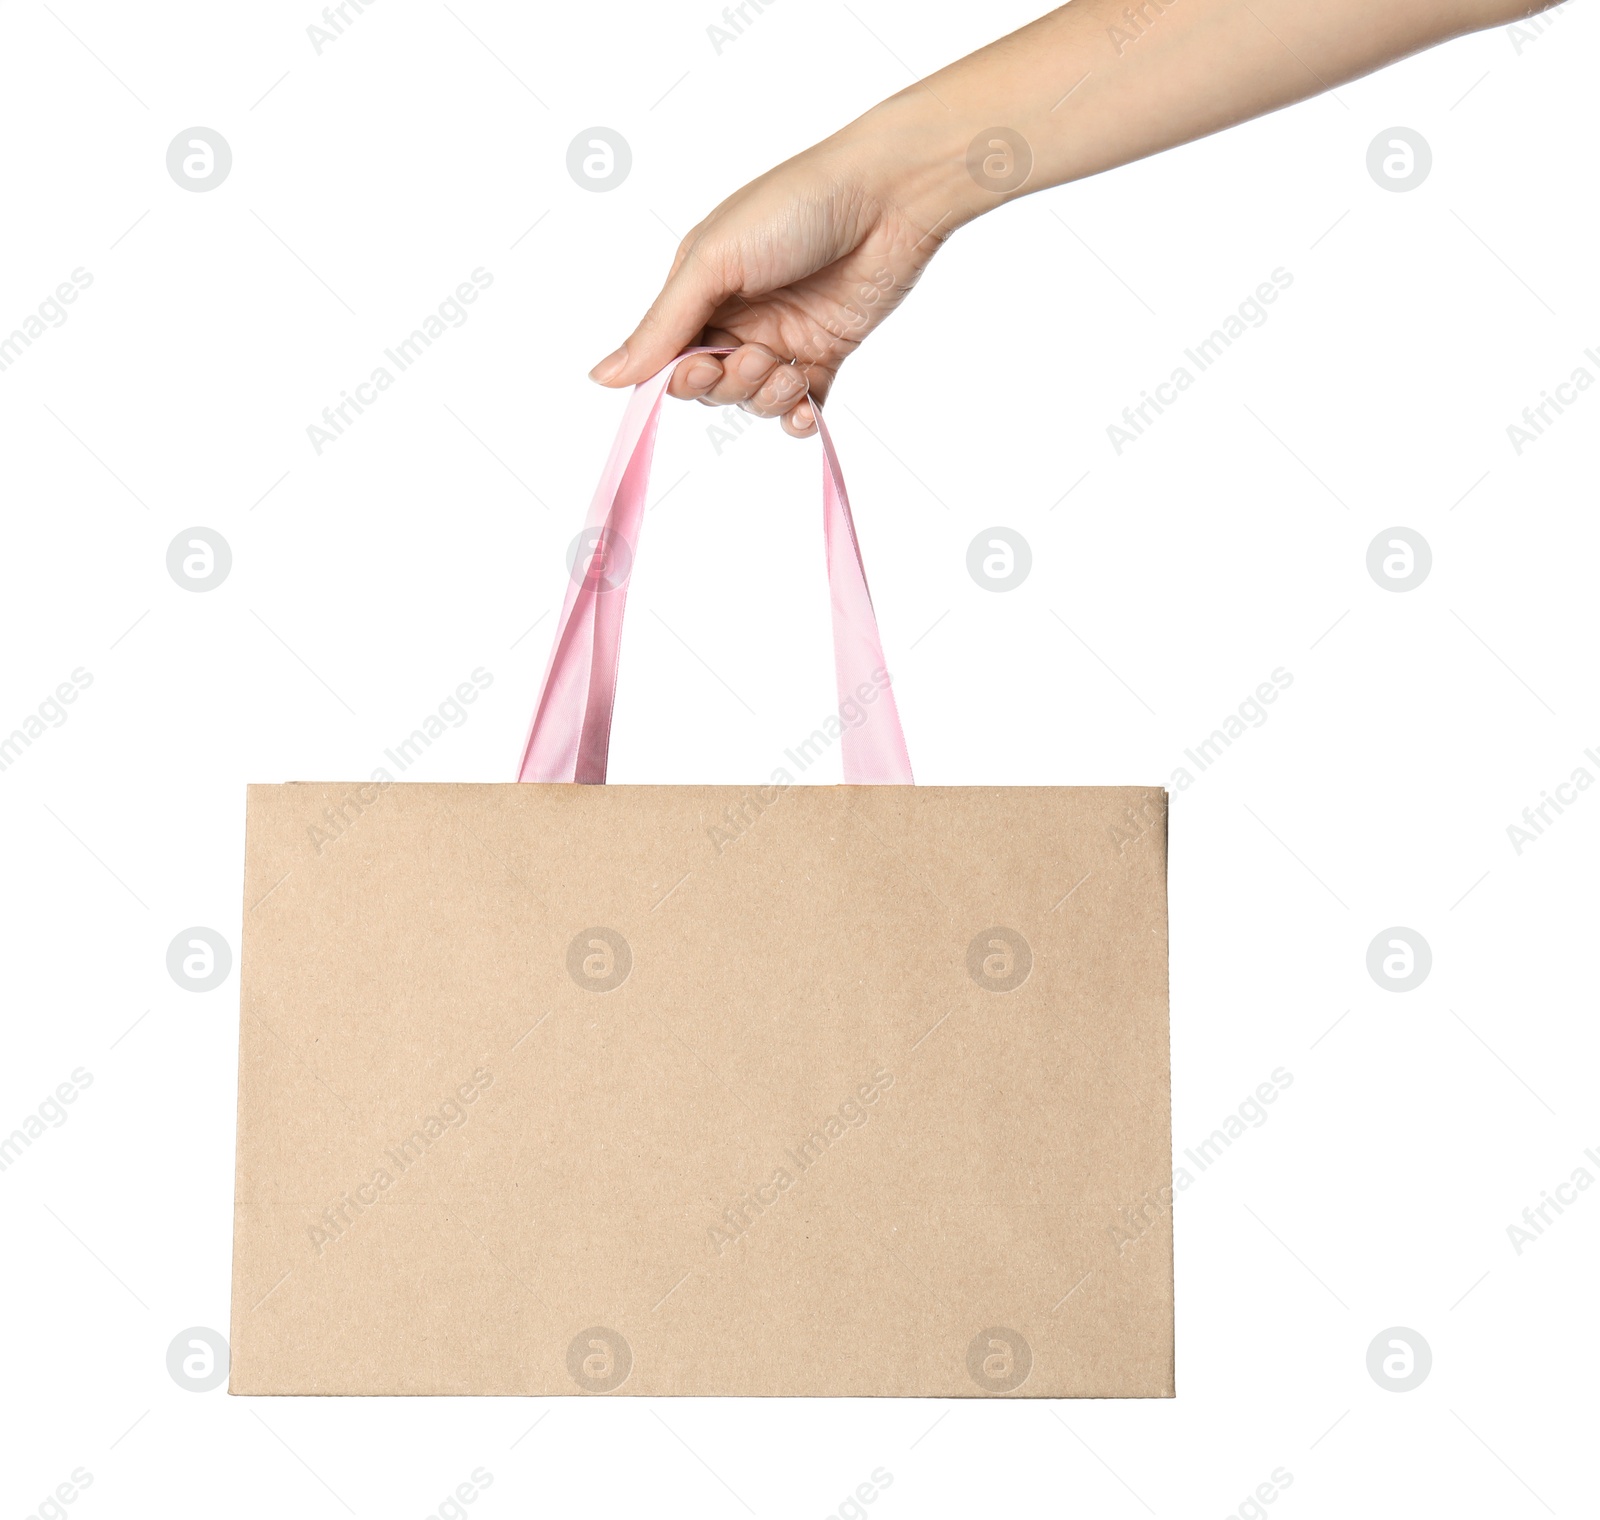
[822,0,1539,235]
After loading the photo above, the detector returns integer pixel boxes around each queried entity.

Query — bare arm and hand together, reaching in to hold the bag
[590,0,1542,438]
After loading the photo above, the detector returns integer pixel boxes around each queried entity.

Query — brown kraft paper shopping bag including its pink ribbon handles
[230,350,1174,1398]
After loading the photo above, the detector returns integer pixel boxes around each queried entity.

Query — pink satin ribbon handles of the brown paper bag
[517,349,912,786]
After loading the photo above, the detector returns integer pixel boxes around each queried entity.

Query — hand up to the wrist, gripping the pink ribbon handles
[590,128,950,438]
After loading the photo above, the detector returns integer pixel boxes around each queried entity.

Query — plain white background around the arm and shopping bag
[0,0,1600,1520]
